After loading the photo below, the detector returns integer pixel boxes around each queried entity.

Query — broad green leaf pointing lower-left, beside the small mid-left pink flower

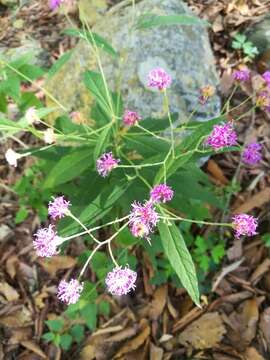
[43,147,93,189]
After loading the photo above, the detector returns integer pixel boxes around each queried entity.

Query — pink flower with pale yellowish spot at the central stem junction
[129,201,158,238]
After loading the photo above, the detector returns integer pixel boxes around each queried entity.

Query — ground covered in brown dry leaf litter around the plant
[0,1,270,360]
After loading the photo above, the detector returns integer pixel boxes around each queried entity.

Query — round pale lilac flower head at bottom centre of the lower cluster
[105,266,137,296]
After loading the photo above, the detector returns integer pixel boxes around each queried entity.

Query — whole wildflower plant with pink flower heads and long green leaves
[0,6,262,306]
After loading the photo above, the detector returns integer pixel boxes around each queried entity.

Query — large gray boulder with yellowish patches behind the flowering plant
[47,0,220,120]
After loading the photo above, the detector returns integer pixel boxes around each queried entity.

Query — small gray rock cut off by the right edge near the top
[247,15,270,54]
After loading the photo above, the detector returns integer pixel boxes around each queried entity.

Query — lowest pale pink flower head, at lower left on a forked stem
[57,279,83,305]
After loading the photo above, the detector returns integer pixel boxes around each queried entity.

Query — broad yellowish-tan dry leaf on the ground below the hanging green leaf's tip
[179,312,226,349]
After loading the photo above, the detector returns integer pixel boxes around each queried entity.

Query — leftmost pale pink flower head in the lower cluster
[33,225,60,257]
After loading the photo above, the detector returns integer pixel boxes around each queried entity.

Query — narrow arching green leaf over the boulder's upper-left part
[64,29,118,57]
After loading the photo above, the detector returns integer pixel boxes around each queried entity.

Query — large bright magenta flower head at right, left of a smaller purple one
[206,123,237,150]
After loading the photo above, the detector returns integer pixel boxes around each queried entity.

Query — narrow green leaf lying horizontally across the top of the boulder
[136,14,209,29]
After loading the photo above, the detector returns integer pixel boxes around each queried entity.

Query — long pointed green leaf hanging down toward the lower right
[158,221,200,306]
